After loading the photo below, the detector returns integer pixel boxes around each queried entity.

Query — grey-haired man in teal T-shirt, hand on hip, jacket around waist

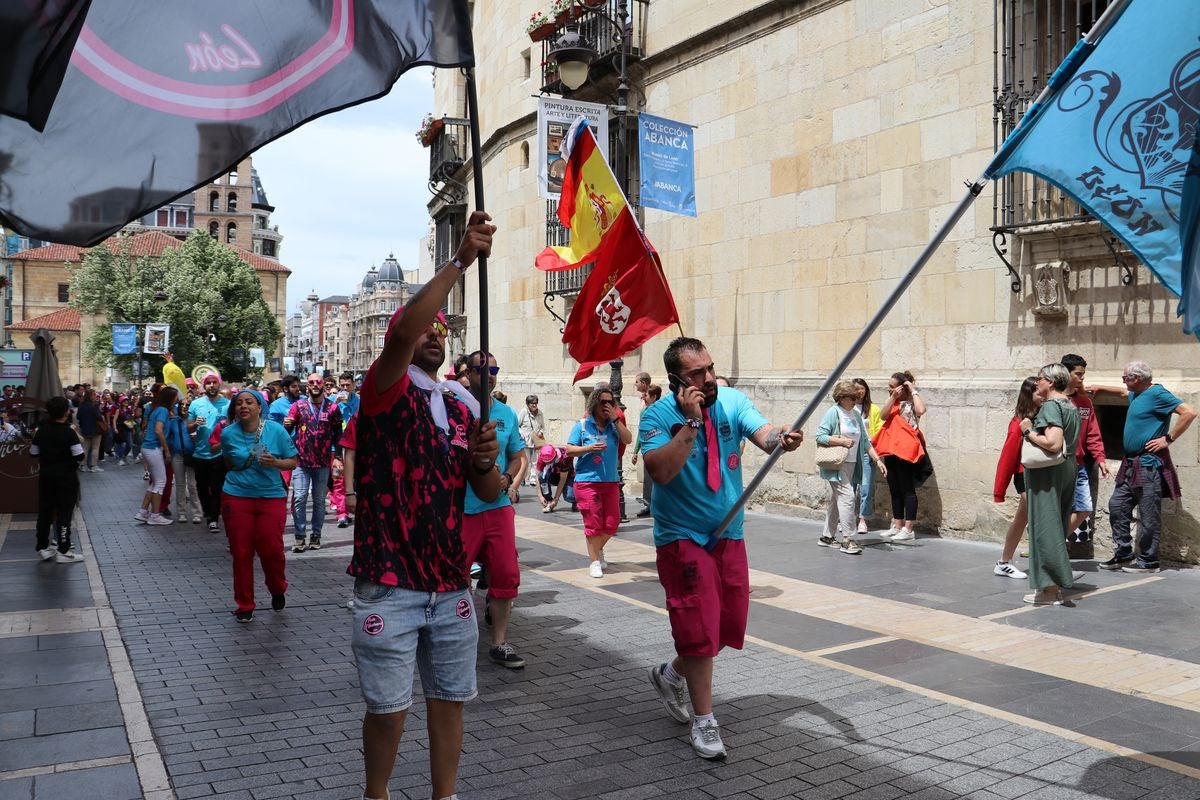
[1094,361,1196,573]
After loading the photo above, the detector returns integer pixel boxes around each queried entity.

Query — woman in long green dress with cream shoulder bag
[1021,363,1079,606]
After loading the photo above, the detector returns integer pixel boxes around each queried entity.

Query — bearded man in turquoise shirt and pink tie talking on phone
[638,337,804,759]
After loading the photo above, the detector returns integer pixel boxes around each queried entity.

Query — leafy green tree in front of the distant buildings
[71,230,280,380]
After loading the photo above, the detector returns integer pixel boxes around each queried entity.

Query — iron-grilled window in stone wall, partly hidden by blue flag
[992,0,1110,231]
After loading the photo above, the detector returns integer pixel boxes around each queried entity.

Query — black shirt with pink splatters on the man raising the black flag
[347,366,474,591]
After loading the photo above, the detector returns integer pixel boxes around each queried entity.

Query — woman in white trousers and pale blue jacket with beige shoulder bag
[816,380,888,555]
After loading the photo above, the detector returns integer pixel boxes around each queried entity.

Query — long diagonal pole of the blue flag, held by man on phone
[710,0,1132,545]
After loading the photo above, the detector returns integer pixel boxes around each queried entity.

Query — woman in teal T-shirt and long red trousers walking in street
[221,389,296,622]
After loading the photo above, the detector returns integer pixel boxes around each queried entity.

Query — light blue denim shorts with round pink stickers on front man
[350,578,479,714]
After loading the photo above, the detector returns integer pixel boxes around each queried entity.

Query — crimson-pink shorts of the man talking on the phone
[658,539,750,658]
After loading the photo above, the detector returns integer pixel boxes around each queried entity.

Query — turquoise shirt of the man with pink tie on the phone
[637,386,767,547]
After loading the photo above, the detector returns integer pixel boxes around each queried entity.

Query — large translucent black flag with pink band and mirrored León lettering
[0,0,474,246]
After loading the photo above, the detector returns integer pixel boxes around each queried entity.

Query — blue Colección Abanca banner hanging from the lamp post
[637,113,696,217]
